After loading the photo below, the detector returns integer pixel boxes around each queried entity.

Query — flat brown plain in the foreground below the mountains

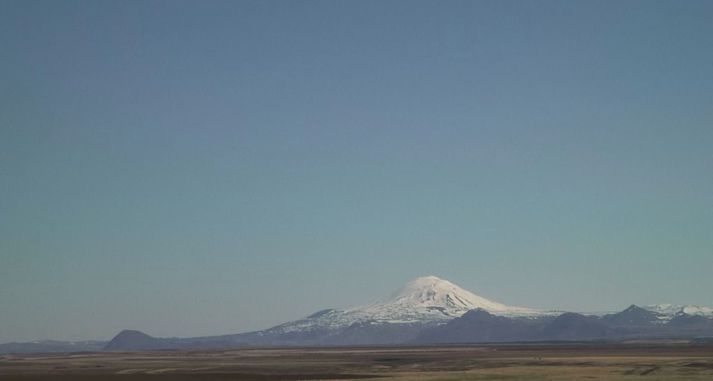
[0,343,713,381]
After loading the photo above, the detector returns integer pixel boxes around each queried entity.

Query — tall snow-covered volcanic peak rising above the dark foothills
[271,276,549,333]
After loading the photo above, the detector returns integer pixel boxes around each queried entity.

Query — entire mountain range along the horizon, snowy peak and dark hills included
[0,275,713,353]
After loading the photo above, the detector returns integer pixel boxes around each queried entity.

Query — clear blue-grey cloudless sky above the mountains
[0,0,713,342]
